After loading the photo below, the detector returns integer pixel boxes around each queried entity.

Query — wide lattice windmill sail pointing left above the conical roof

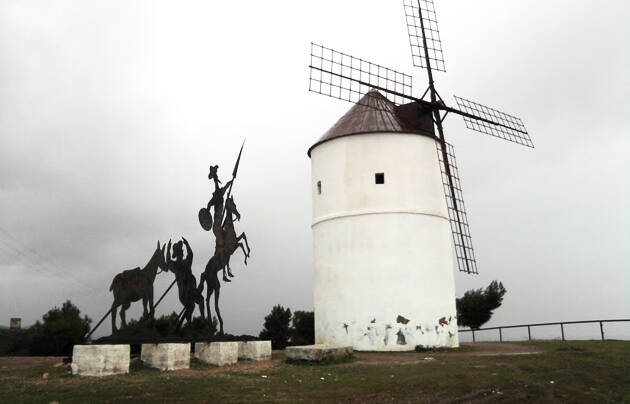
[309,43,414,105]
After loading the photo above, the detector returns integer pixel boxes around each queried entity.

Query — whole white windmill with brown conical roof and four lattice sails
[308,0,533,351]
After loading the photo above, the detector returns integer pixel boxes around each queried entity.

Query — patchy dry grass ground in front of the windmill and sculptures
[0,341,630,403]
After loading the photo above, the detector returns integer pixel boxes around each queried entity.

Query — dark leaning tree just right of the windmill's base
[455,281,507,329]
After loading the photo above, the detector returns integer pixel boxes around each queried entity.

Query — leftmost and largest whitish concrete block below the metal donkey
[70,344,130,376]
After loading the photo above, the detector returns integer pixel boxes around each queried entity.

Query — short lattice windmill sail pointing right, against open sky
[452,96,534,148]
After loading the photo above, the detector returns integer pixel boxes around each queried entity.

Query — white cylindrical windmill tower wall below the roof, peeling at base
[311,133,458,351]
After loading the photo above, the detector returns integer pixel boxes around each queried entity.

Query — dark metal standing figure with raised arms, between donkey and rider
[166,237,205,328]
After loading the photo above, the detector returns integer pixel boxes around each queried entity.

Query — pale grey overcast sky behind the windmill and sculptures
[0,0,630,335]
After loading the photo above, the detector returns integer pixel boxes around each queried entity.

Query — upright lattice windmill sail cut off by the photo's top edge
[403,0,446,72]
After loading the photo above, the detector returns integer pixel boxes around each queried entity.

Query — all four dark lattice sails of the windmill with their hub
[309,0,534,274]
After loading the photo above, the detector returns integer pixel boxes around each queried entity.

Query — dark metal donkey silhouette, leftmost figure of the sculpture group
[108,241,166,334]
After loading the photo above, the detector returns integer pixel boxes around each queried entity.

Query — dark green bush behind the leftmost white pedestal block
[28,300,92,355]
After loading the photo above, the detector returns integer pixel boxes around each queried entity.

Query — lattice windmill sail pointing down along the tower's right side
[436,141,478,274]
